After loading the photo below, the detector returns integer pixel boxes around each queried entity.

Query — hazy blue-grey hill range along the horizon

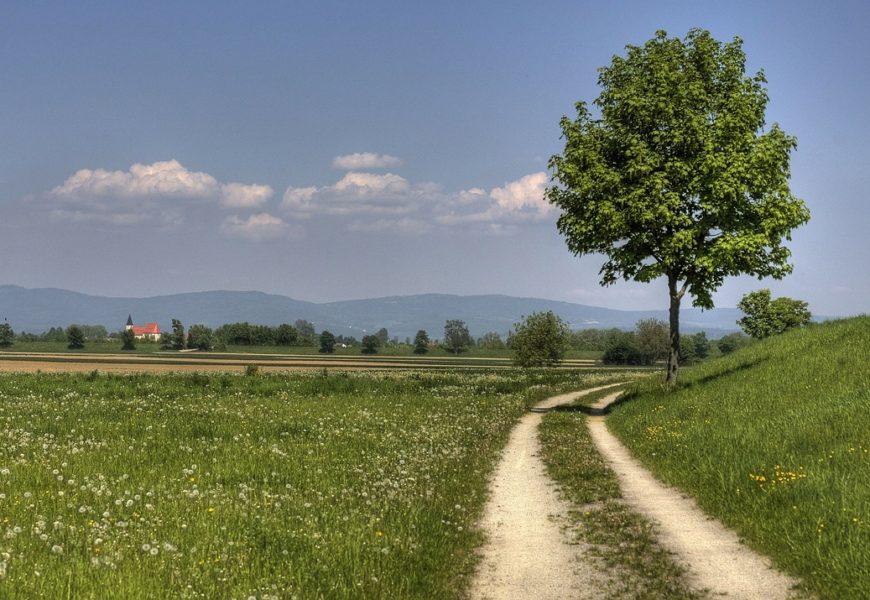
[0,285,740,339]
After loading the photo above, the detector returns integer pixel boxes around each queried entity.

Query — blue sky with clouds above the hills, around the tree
[0,0,870,316]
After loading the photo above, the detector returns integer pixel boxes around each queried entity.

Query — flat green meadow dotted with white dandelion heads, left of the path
[0,370,619,600]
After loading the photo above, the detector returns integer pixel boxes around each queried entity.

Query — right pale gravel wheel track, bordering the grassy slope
[587,393,797,600]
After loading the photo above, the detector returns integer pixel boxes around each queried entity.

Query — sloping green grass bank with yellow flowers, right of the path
[608,317,870,600]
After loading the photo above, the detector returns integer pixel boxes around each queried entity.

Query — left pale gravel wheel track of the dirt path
[471,384,621,600]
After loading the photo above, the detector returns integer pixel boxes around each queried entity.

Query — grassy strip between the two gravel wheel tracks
[540,390,703,599]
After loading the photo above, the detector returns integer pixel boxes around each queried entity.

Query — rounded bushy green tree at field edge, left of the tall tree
[511,311,571,367]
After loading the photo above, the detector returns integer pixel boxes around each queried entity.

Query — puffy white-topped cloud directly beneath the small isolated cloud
[282,171,420,216]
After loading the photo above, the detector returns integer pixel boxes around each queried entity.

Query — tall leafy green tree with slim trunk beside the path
[546,29,809,386]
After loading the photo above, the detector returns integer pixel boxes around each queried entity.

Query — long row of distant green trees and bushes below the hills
[0,289,811,367]
